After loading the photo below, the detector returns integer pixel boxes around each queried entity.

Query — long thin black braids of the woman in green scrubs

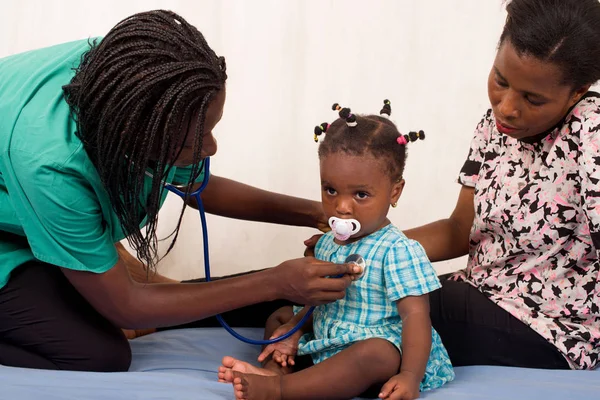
[63,10,227,270]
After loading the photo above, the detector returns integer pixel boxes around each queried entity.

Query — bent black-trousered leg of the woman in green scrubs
[0,262,131,372]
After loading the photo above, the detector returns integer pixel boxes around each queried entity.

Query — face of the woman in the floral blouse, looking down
[488,40,589,139]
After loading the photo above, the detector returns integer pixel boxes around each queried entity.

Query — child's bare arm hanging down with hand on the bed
[380,295,431,399]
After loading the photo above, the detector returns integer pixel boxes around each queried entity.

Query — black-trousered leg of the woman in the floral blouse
[429,275,569,369]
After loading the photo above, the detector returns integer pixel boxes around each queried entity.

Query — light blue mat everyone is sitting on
[0,329,600,400]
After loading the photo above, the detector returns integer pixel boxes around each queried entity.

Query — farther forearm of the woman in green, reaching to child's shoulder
[187,175,327,230]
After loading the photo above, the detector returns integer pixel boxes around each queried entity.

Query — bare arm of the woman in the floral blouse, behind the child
[404,186,475,262]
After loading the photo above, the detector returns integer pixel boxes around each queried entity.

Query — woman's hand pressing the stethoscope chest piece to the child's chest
[272,257,362,306]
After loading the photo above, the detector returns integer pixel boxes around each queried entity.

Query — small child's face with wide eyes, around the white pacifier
[321,153,404,241]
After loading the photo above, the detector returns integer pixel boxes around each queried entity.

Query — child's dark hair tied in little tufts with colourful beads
[314,100,425,181]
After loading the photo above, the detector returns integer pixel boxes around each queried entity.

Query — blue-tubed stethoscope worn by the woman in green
[146,157,365,345]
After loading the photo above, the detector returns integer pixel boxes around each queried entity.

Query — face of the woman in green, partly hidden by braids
[173,88,226,167]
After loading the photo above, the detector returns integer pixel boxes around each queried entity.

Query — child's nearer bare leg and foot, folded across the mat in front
[233,339,401,400]
